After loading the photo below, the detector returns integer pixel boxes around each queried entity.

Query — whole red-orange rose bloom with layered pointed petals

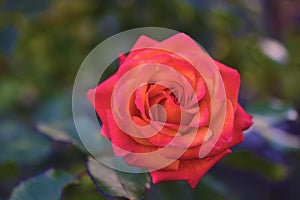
[87,34,252,188]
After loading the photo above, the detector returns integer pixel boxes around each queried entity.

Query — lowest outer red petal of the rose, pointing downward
[150,149,231,188]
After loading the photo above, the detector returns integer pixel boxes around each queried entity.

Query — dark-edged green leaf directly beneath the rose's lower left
[87,157,150,200]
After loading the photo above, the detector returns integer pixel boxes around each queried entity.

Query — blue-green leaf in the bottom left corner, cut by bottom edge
[10,170,76,200]
